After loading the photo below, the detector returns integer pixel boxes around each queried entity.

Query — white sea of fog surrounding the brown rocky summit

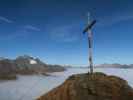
[0,68,133,100]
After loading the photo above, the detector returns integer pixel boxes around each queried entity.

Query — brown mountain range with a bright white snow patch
[0,55,65,79]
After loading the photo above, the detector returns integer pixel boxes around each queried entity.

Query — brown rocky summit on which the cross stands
[37,73,133,100]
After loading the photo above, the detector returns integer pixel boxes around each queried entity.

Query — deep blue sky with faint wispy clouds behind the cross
[0,0,133,65]
